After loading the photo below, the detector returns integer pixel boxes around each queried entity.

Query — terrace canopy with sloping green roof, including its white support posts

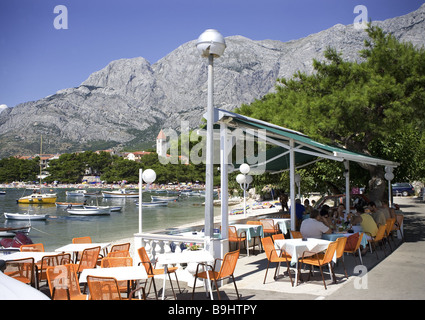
[214,109,399,256]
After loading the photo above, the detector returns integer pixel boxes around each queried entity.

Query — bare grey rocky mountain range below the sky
[0,4,425,157]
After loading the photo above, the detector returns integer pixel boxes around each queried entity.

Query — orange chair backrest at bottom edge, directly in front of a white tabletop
[87,276,122,300]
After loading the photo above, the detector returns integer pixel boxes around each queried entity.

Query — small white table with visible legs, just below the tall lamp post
[157,250,214,300]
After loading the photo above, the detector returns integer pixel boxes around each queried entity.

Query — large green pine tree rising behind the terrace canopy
[238,26,425,199]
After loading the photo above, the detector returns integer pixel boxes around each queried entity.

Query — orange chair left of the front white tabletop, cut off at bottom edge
[46,264,87,300]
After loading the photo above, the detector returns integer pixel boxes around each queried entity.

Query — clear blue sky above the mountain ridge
[0,0,425,107]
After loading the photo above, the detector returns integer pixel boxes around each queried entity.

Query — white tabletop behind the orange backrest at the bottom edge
[79,266,148,298]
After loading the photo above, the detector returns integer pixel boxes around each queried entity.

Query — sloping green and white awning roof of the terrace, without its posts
[216,109,399,172]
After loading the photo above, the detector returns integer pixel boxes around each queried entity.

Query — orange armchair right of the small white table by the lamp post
[192,250,239,300]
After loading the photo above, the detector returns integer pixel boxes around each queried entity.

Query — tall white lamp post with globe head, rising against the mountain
[196,29,226,253]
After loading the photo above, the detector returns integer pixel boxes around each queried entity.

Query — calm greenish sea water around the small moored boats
[0,188,220,251]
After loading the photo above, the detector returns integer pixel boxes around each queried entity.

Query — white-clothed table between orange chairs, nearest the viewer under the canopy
[274,238,335,285]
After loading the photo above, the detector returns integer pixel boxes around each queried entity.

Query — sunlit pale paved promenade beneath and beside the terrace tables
[174,197,425,301]
